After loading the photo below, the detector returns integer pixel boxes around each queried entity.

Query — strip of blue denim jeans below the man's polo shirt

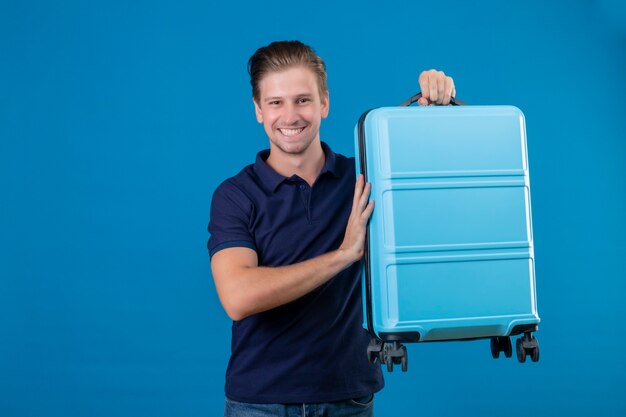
[224,394,374,417]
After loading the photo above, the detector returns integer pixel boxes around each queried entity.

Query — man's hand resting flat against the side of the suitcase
[339,175,374,263]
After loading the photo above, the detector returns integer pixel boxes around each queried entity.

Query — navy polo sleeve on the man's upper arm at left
[207,180,256,257]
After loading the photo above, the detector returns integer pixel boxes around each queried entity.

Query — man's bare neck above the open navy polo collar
[266,140,326,186]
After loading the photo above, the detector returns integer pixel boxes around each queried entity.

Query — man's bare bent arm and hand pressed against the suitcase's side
[211,175,374,321]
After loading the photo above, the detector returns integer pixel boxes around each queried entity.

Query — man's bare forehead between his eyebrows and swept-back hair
[259,66,319,100]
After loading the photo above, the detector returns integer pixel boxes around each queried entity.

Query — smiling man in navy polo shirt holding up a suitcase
[208,41,455,416]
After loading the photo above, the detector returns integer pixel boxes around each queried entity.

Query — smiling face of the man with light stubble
[254,66,329,156]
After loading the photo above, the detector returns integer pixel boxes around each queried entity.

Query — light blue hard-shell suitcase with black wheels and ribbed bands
[355,94,540,371]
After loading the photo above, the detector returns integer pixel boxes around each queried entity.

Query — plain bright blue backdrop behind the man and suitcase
[0,0,626,417]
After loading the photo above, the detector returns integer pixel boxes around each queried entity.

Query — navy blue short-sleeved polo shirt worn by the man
[208,143,383,403]
